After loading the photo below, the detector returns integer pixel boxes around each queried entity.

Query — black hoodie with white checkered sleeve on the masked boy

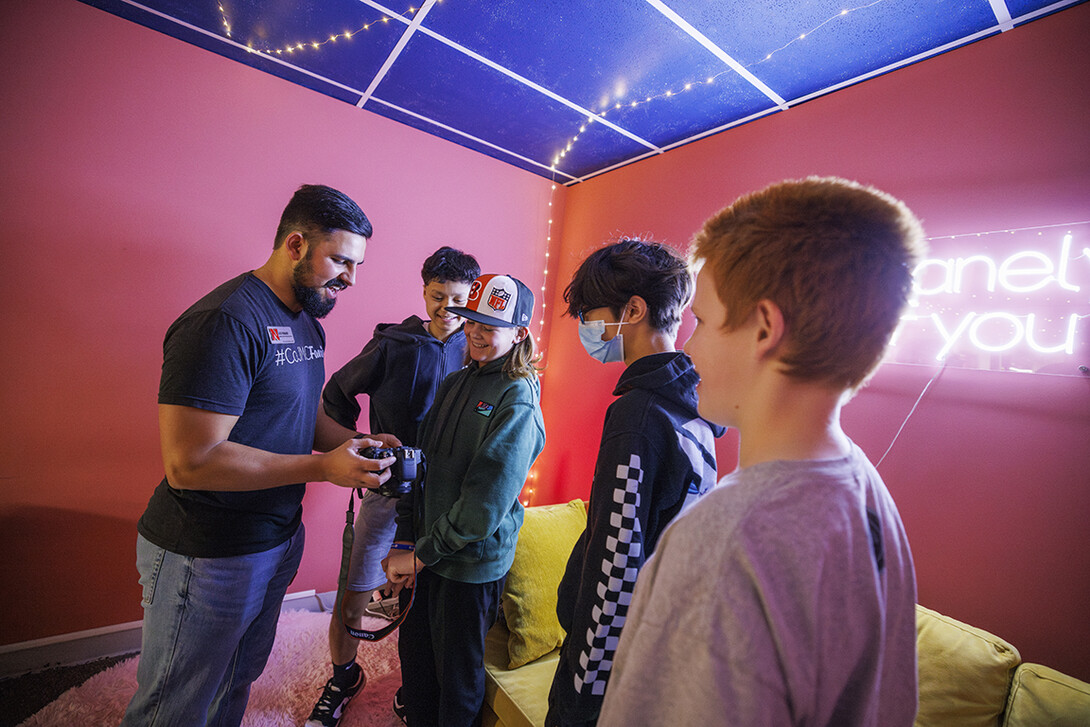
[546,351,725,725]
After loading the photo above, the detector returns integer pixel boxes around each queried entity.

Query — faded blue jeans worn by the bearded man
[121,524,305,727]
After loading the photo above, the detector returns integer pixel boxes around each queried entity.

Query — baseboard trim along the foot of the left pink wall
[0,589,337,679]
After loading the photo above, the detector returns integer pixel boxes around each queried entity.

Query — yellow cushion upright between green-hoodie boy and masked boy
[504,500,586,667]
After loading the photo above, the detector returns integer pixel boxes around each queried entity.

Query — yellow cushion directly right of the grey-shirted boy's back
[916,606,1021,727]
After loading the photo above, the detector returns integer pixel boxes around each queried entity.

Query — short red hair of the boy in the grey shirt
[693,177,927,389]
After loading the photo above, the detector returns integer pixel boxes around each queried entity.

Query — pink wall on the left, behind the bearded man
[0,0,564,644]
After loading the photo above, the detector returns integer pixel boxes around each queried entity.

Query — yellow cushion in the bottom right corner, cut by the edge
[1003,664,1090,727]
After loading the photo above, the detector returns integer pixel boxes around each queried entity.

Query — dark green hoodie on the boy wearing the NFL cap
[396,353,545,583]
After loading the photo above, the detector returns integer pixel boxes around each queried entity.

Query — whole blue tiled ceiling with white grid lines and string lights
[72,0,1085,184]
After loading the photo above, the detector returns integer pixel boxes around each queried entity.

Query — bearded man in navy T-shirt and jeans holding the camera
[122,185,399,727]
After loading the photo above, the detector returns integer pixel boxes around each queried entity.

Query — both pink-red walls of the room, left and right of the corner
[0,0,1090,679]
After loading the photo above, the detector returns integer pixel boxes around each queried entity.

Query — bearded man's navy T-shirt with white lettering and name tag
[137,272,325,558]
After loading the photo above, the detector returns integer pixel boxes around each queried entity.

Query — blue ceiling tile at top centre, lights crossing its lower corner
[425,0,784,146]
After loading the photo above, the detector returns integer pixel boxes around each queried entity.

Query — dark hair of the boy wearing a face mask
[564,239,693,332]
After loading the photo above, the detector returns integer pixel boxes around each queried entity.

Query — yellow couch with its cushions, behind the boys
[484,500,1090,727]
